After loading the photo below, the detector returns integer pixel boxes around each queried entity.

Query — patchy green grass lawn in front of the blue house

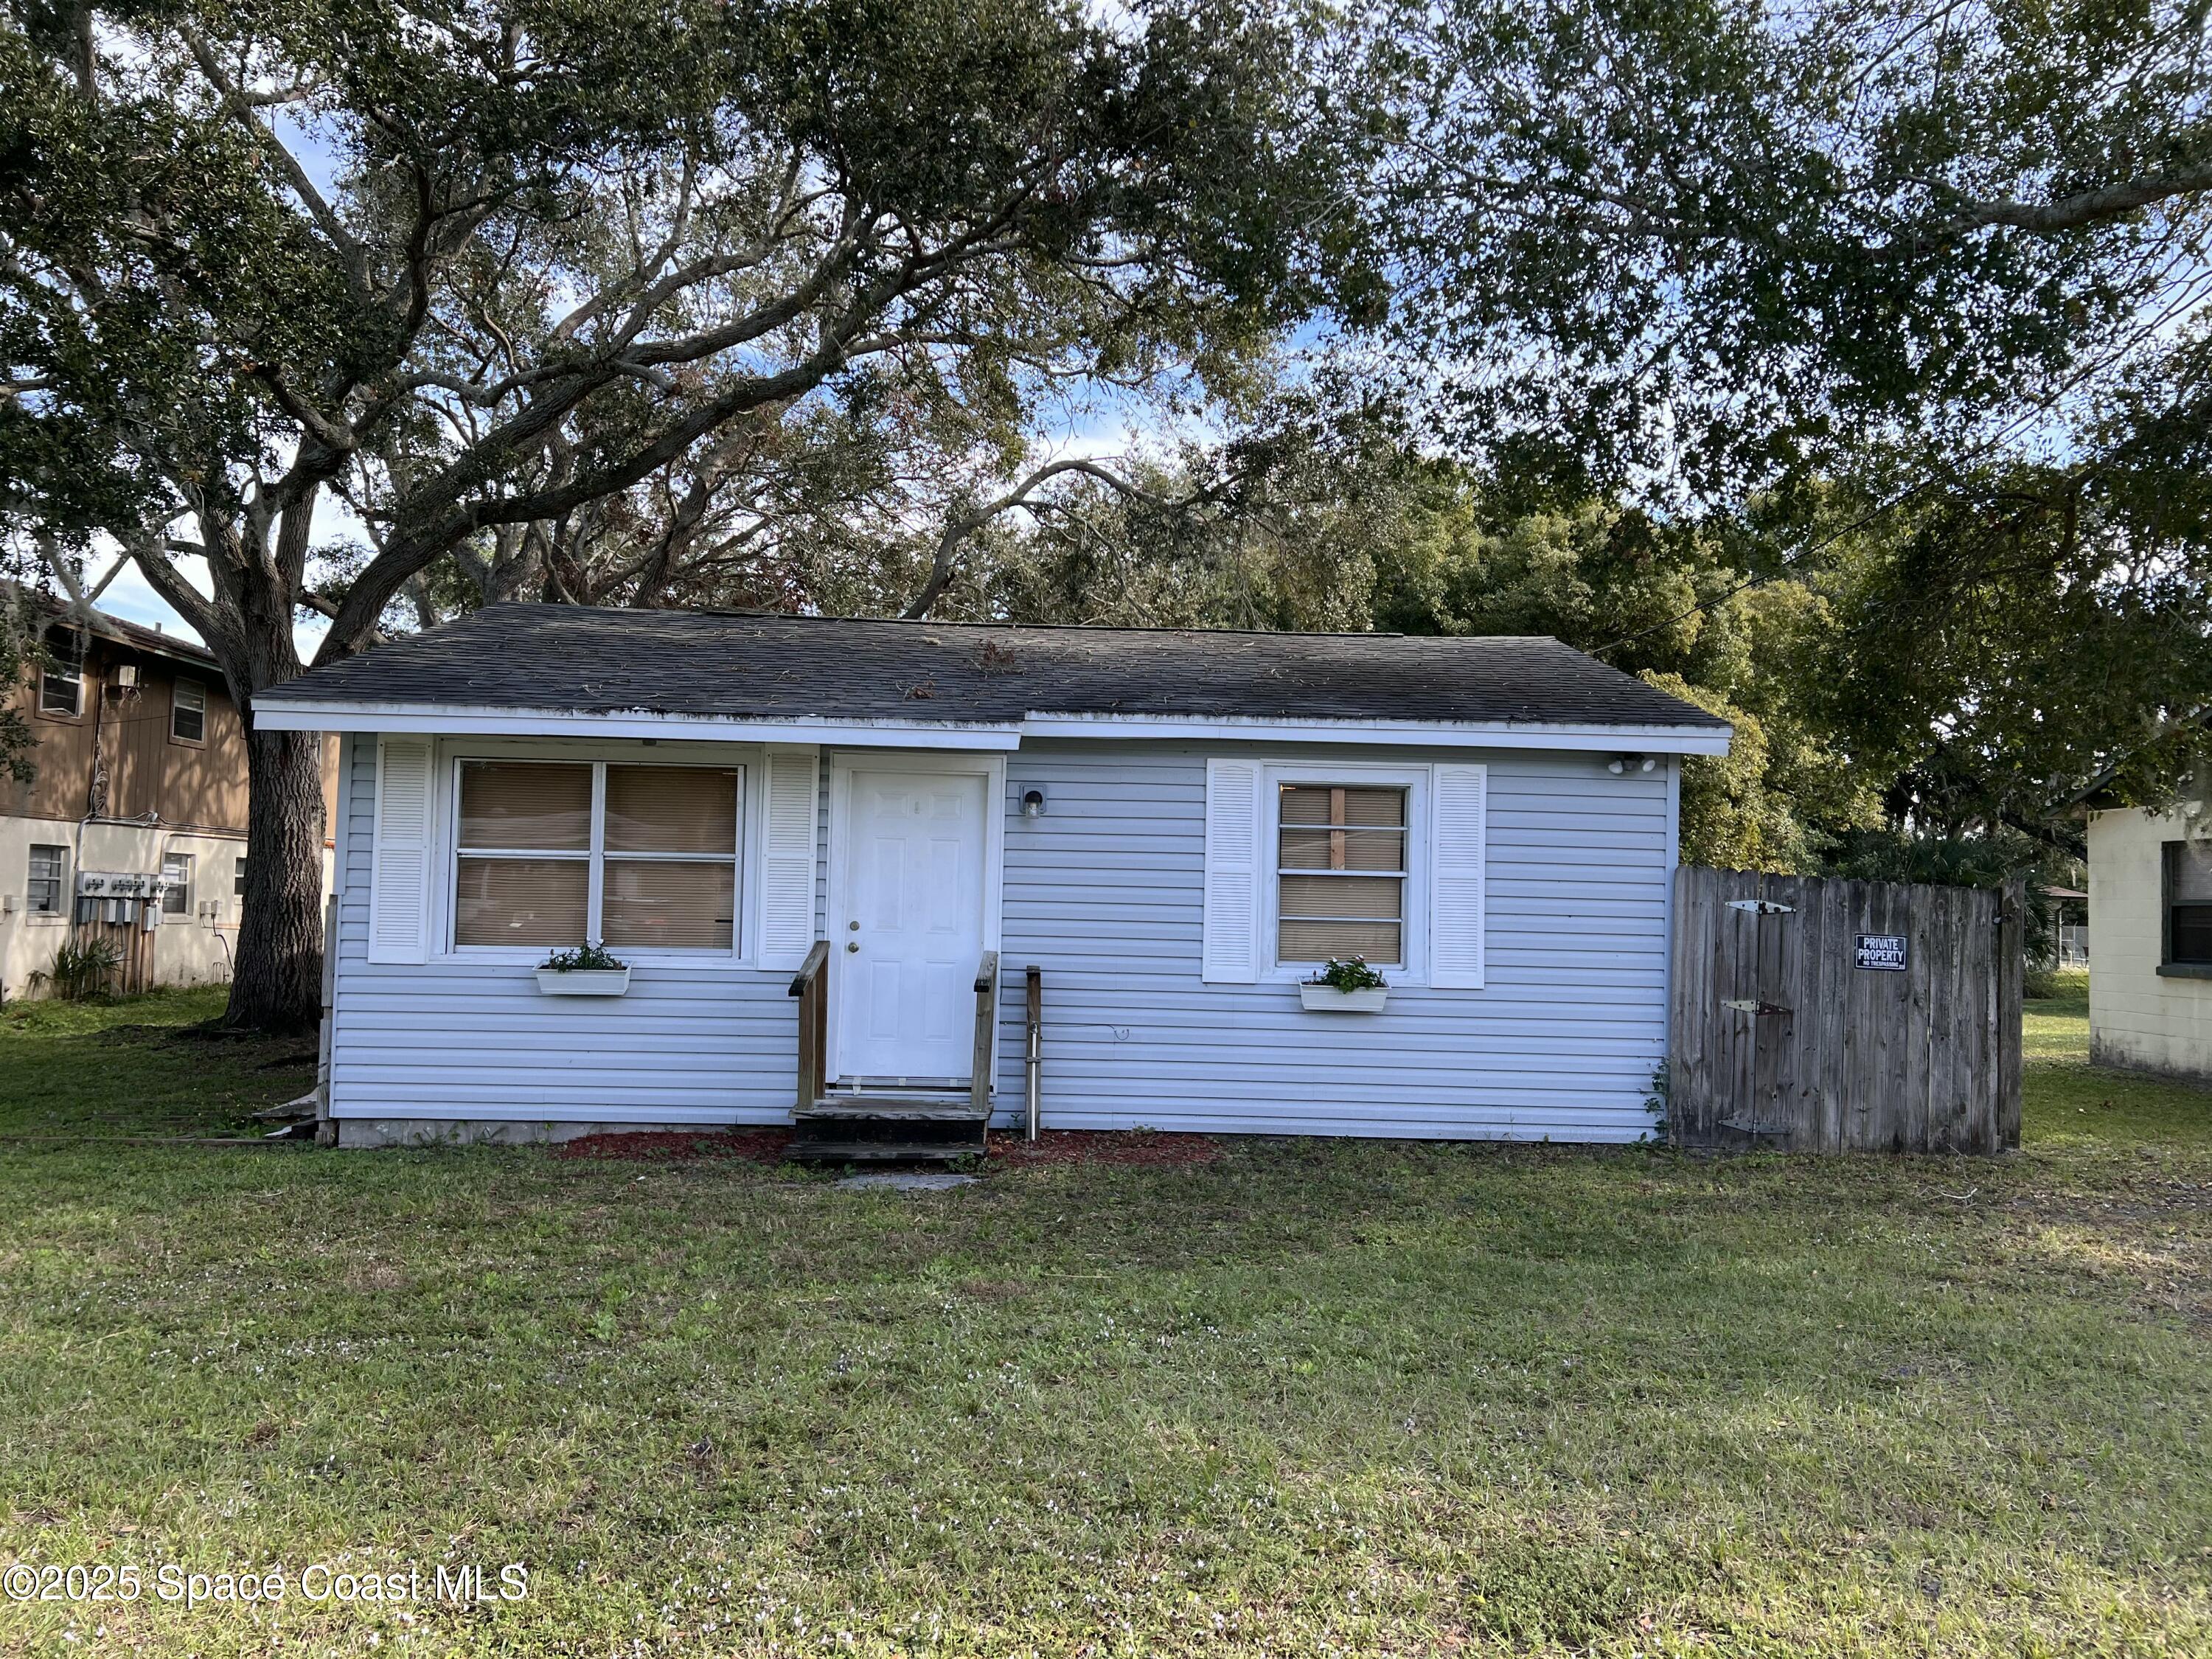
[0,995,2212,1659]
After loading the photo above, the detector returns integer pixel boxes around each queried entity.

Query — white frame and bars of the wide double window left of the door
[429,739,763,969]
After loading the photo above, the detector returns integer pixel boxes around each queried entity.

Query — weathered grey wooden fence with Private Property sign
[1668,865,2024,1152]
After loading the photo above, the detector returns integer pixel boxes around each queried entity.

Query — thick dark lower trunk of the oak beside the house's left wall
[223,726,323,1031]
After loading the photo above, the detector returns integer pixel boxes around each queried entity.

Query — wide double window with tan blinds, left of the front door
[453,761,741,953]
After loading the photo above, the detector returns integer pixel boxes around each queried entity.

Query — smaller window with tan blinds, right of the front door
[1274,783,1407,967]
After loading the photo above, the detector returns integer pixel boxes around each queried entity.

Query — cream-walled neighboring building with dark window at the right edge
[2088,807,2212,1082]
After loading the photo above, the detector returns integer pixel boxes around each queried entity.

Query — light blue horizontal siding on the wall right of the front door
[1000,739,1672,1141]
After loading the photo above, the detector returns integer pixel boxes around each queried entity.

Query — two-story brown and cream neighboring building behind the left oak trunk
[0,613,338,998]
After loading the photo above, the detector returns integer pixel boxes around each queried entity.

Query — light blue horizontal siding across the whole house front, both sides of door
[332,739,1672,1141]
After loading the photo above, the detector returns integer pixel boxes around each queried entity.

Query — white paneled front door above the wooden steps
[830,768,989,1082]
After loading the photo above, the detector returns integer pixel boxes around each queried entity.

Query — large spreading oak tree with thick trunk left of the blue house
[0,0,1347,1024]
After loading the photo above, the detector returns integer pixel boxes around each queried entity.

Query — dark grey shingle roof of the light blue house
[279,604,1725,730]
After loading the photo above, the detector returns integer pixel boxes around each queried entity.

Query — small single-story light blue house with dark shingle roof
[254,604,1730,1146]
